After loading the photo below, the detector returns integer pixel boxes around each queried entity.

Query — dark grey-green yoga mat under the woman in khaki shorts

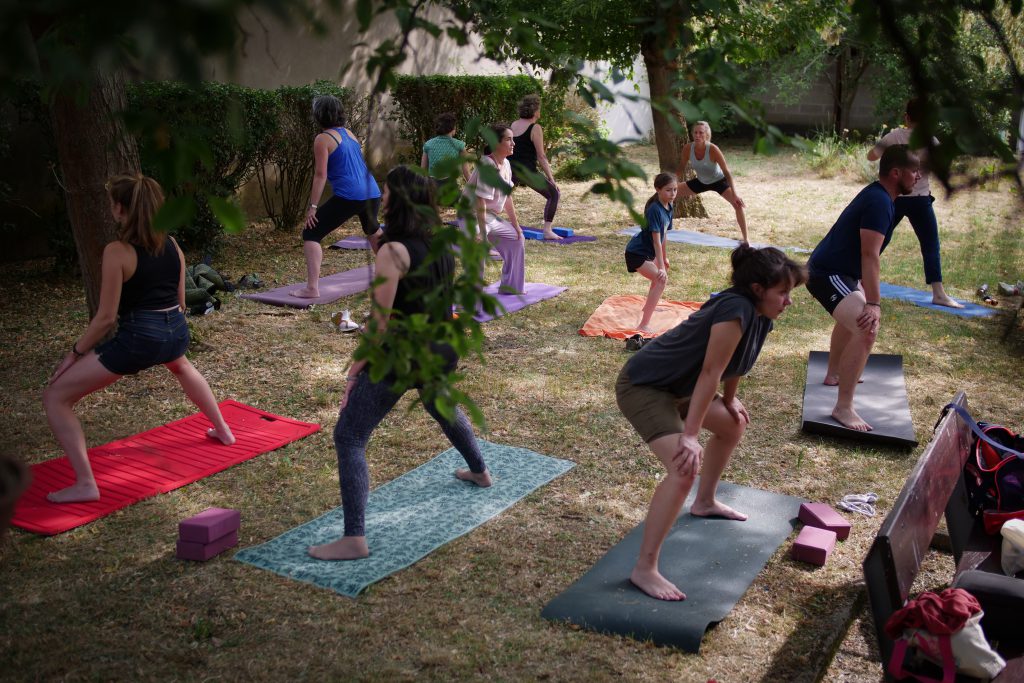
[541,481,806,652]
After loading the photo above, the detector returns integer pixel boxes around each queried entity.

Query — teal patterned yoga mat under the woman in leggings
[234,440,575,598]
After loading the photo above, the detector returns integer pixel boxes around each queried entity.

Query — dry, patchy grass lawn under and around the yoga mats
[0,141,1024,683]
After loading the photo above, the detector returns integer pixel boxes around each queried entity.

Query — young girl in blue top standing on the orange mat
[626,173,679,335]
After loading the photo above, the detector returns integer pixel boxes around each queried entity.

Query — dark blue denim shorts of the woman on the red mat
[96,308,188,375]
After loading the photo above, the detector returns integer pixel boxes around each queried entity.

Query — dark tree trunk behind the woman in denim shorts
[51,73,139,317]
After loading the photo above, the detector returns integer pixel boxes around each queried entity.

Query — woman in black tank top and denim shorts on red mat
[43,174,234,503]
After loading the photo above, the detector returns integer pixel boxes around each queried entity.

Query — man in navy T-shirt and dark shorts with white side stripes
[807,144,921,431]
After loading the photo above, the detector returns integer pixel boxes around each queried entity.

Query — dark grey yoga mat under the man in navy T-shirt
[802,351,918,447]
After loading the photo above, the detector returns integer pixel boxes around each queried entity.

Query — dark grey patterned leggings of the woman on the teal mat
[334,371,485,536]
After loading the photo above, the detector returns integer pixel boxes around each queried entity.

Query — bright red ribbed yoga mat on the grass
[11,400,319,536]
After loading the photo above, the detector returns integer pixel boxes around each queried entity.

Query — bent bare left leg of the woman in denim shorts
[43,352,121,503]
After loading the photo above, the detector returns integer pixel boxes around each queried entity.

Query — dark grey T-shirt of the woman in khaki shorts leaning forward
[626,289,772,398]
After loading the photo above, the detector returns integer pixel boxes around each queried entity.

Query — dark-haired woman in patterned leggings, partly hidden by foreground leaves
[308,166,490,560]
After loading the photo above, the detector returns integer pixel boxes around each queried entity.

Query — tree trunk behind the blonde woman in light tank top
[640,39,708,218]
